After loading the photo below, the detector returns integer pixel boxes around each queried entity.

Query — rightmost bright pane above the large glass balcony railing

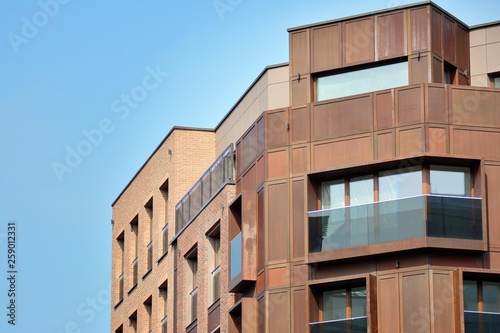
[430,165,471,196]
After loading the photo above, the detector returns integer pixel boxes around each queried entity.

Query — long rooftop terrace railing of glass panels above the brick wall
[175,144,234,234]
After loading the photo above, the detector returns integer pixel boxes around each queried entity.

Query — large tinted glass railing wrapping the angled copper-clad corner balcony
[308,195,482,253]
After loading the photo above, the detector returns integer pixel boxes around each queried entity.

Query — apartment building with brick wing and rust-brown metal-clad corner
[111,2,500,333]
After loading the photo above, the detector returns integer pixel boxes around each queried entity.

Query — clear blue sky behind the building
[0,0,500,333]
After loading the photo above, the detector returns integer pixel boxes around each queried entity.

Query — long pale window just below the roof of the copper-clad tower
[316,61,408,101]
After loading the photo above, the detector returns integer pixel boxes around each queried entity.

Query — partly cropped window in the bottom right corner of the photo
[463,278,500,333]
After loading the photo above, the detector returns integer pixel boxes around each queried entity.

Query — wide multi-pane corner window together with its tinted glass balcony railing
[308,164,482,253]
